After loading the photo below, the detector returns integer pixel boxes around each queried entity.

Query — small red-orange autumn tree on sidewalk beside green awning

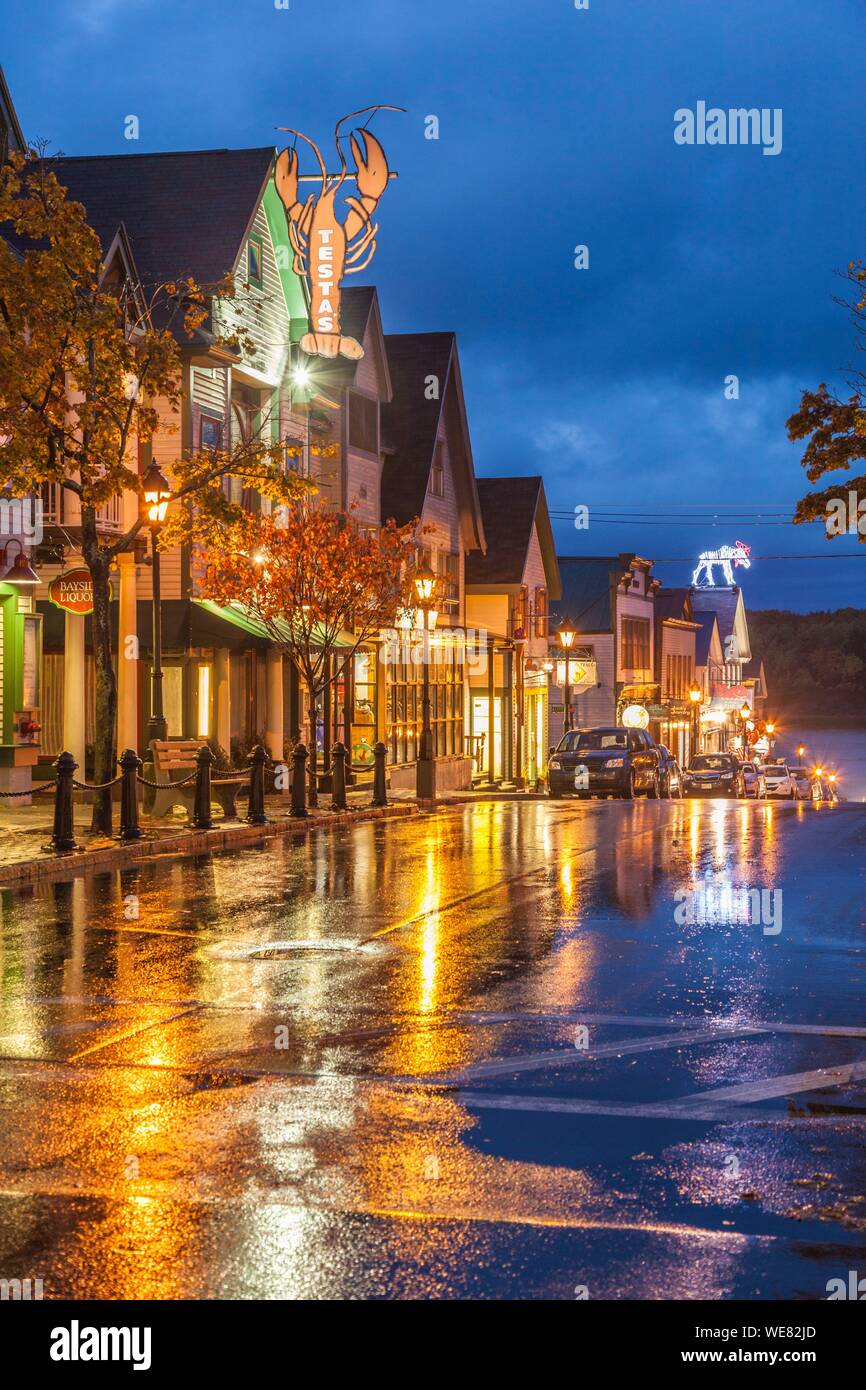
[202,500,416,805]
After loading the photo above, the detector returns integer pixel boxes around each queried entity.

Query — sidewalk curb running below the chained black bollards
[0,802,418,888]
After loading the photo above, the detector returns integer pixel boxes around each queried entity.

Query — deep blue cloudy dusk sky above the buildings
[0,0,866,610]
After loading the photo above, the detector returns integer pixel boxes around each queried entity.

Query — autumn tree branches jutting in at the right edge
[788,261,866,541]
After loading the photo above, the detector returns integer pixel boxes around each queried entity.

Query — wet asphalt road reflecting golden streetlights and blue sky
[0,801,866,1300]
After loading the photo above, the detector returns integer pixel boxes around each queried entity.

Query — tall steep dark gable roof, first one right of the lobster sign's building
[381,332,487,550]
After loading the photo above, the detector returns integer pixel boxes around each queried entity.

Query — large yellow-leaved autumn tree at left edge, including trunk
[0,152,304,833]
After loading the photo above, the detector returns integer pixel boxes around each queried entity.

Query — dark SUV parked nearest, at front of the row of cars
[548,726,662,798]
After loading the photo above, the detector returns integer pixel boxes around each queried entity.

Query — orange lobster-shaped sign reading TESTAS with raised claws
[274,106,403,360]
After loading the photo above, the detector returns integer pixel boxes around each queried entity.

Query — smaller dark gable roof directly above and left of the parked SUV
[466,477,562,599]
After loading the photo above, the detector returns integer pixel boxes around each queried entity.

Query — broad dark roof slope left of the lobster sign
[42,146,275,291]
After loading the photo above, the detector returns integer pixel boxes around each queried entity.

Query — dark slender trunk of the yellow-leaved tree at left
[79,507,117,835]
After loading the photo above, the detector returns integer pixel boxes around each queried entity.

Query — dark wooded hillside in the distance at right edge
[748,609,866,721]
